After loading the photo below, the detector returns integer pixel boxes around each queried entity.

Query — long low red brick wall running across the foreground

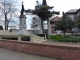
[0,40,80,60]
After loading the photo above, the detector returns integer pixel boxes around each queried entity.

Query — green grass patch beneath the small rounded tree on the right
[50,35,80,42]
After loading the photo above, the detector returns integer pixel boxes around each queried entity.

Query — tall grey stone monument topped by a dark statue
[17,2,30,41]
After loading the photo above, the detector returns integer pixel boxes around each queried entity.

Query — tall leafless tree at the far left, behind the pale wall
[0,0,17,30]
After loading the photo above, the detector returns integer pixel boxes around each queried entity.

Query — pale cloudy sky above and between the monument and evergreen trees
[17,0,80,29]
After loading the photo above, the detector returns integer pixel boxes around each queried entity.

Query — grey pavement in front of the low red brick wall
[0,48,57,60]
